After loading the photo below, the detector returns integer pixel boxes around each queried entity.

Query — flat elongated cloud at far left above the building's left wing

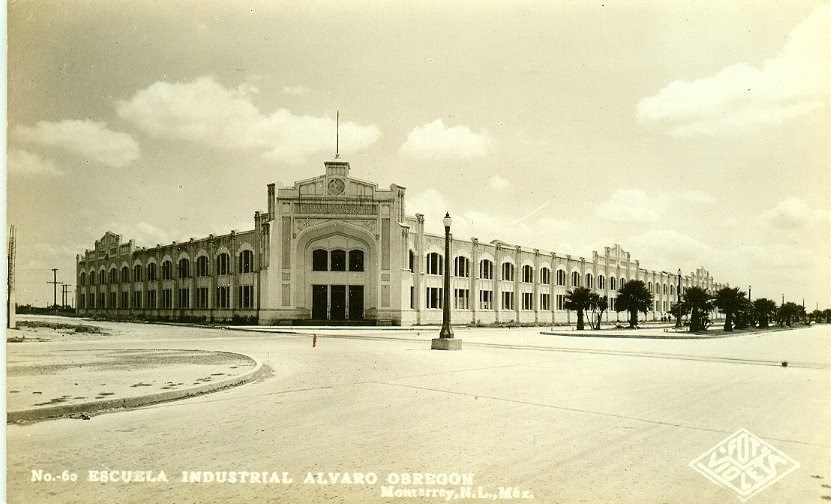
[14,119,139,168]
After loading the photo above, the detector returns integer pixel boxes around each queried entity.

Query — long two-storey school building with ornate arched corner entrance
[76,159,723,325]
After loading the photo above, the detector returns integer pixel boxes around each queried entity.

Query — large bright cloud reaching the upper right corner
[636,4,831,136]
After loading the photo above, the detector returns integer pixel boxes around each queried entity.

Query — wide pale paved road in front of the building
[7,324,831,503]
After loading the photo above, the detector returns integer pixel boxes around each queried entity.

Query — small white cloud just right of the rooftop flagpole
[401,119,491,159]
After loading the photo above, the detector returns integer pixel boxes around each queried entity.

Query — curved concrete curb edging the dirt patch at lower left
[6,354,264,423]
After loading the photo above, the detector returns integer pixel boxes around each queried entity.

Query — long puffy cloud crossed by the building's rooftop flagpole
[116,76,380,162]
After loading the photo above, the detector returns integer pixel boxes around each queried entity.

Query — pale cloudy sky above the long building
[6,0,831,308]
